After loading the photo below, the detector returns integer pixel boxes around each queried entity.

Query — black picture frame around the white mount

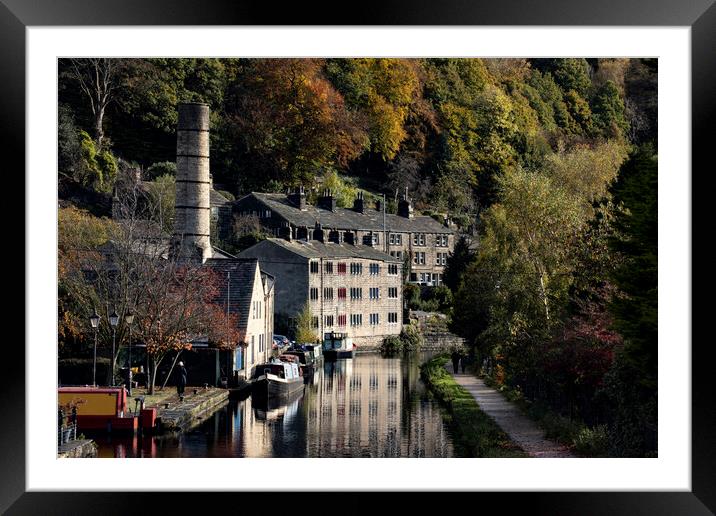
[0,0,716,514]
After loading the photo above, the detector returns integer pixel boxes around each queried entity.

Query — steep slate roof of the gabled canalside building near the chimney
[204,258,259,330]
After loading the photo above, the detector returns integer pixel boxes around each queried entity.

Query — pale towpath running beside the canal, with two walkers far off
[446,364,575,457]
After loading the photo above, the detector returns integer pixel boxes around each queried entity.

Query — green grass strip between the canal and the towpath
[420,355,527,457]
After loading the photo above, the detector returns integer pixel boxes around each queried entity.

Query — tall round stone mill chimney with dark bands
[173,103,212,262]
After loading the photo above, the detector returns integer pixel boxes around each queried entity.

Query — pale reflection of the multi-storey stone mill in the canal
[306,355,452,457]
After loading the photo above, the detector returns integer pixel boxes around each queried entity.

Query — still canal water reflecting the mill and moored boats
[97,354,453,458]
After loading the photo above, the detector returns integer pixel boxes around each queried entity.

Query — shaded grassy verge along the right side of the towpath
[482,376,610,457]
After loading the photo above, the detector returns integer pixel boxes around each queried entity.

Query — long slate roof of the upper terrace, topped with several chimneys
[234,192,454,234]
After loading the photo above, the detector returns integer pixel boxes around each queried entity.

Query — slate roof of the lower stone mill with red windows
[239,238,402,263]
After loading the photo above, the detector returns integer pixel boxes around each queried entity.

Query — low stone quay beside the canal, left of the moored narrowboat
[157,387,229,432]
